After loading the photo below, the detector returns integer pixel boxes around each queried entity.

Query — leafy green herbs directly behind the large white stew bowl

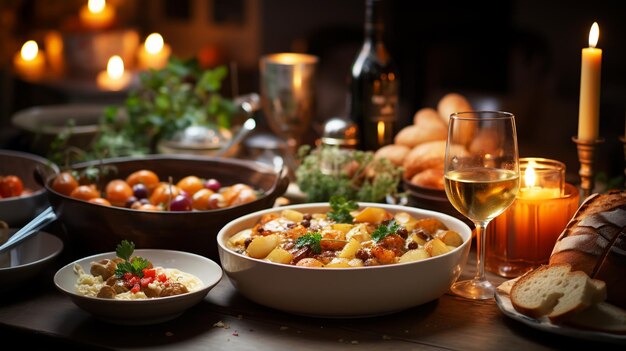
[296,145,403,202]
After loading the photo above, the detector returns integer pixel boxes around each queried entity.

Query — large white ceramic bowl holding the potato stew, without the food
[217,203,471,318]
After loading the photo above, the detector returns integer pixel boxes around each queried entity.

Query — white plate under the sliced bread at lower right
[496,292,626,344]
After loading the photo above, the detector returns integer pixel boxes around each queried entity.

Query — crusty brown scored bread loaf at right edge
[550,191,626,308]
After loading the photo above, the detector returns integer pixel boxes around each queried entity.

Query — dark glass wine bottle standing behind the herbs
[350,0,399,150]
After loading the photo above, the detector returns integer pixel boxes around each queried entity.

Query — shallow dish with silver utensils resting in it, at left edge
[0,228,63,291]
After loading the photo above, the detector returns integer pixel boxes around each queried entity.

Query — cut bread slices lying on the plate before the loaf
[510,264,606,323]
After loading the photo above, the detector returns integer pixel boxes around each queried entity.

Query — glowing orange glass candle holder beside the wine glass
[485,157,580,278]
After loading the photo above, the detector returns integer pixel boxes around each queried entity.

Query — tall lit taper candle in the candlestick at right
[578,22,602,141]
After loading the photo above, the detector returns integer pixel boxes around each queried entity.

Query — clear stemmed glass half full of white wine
[444,111,519,300]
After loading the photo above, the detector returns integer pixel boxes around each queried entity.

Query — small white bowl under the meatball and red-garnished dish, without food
[54,249,222,325]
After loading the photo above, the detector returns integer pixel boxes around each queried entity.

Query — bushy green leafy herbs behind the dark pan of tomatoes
[51,58,236,163]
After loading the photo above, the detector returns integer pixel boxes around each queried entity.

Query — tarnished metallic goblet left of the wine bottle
[260,53,318,179]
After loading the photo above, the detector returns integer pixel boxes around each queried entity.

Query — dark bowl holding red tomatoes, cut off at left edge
[0,150,59,228]
